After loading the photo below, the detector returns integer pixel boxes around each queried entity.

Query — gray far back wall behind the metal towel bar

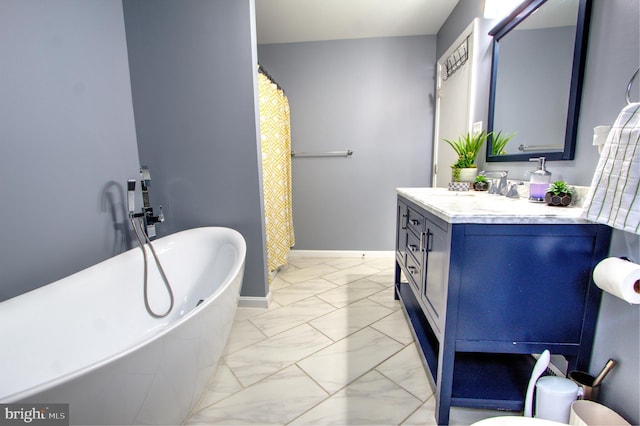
[258,36,436,250]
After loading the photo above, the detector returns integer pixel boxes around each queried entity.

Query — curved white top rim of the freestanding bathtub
[0,226,247,404]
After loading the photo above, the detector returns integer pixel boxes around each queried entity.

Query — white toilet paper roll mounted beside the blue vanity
[593,257,640,304]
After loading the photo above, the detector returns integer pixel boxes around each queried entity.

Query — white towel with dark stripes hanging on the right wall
[582,103,640,235]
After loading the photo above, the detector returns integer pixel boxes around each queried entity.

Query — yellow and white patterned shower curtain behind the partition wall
[258,72,295,276]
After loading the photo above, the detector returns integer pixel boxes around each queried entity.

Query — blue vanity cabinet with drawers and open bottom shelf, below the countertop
[395,194,611,424]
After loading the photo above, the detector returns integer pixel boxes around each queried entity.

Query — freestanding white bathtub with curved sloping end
[0,227,246,425]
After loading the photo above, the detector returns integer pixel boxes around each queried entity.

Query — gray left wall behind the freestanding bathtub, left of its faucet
[0,0,138,300]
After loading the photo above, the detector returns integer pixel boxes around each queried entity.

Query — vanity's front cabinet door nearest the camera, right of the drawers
[422,216,449,329]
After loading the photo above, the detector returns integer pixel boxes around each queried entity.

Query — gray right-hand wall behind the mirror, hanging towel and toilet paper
[438,0,640,424]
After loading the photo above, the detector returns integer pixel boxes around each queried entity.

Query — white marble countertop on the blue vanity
[397,188,592,224]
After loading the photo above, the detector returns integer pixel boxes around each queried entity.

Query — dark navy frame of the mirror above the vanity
[486,0,591,162]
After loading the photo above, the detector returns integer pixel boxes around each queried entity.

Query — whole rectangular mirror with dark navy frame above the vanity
[486,0,591,162]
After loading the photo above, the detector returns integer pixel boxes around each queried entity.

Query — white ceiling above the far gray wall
[255,0,458,44]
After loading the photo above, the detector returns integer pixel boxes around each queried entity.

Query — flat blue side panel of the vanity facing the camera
[457,225,597,344]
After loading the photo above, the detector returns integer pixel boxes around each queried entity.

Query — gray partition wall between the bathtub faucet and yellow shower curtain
[123,0,267,297]
